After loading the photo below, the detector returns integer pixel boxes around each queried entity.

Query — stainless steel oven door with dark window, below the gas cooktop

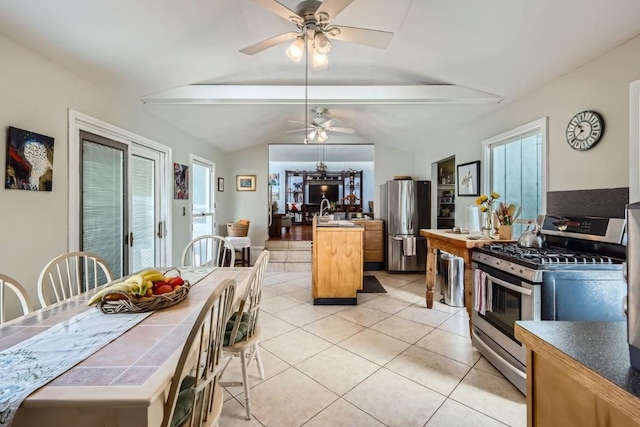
[472,263,540,365]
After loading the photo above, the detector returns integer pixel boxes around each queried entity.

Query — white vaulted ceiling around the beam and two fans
[0,0,640,152]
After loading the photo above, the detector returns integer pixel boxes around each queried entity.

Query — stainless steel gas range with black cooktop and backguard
[471,215,626,393]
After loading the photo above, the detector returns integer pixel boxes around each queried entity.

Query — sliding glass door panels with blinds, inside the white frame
[80,132,165,277]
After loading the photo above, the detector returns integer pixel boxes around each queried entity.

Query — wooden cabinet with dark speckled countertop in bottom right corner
[515,321,640,427]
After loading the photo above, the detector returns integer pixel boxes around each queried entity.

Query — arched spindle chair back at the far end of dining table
[182,234,236,267]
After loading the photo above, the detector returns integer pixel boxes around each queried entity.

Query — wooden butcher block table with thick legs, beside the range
[420,229,513,326]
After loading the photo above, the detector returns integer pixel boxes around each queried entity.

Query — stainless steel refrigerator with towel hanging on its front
[380,179,431,272]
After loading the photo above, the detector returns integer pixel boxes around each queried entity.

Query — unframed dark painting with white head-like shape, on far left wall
[4,127,53,191]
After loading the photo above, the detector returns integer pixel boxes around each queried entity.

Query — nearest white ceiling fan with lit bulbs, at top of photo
[240,0,393,67]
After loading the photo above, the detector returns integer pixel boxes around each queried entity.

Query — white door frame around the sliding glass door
[67,109,173,266]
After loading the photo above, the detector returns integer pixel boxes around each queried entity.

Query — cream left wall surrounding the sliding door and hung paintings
[0,36,227,314]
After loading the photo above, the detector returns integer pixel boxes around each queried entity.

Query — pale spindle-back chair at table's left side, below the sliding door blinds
[38,252,113,307]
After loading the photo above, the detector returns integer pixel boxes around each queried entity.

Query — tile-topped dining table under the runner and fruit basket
[0,267,252,427]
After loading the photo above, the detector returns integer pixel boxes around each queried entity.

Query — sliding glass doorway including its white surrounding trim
[69,111,171,278]
